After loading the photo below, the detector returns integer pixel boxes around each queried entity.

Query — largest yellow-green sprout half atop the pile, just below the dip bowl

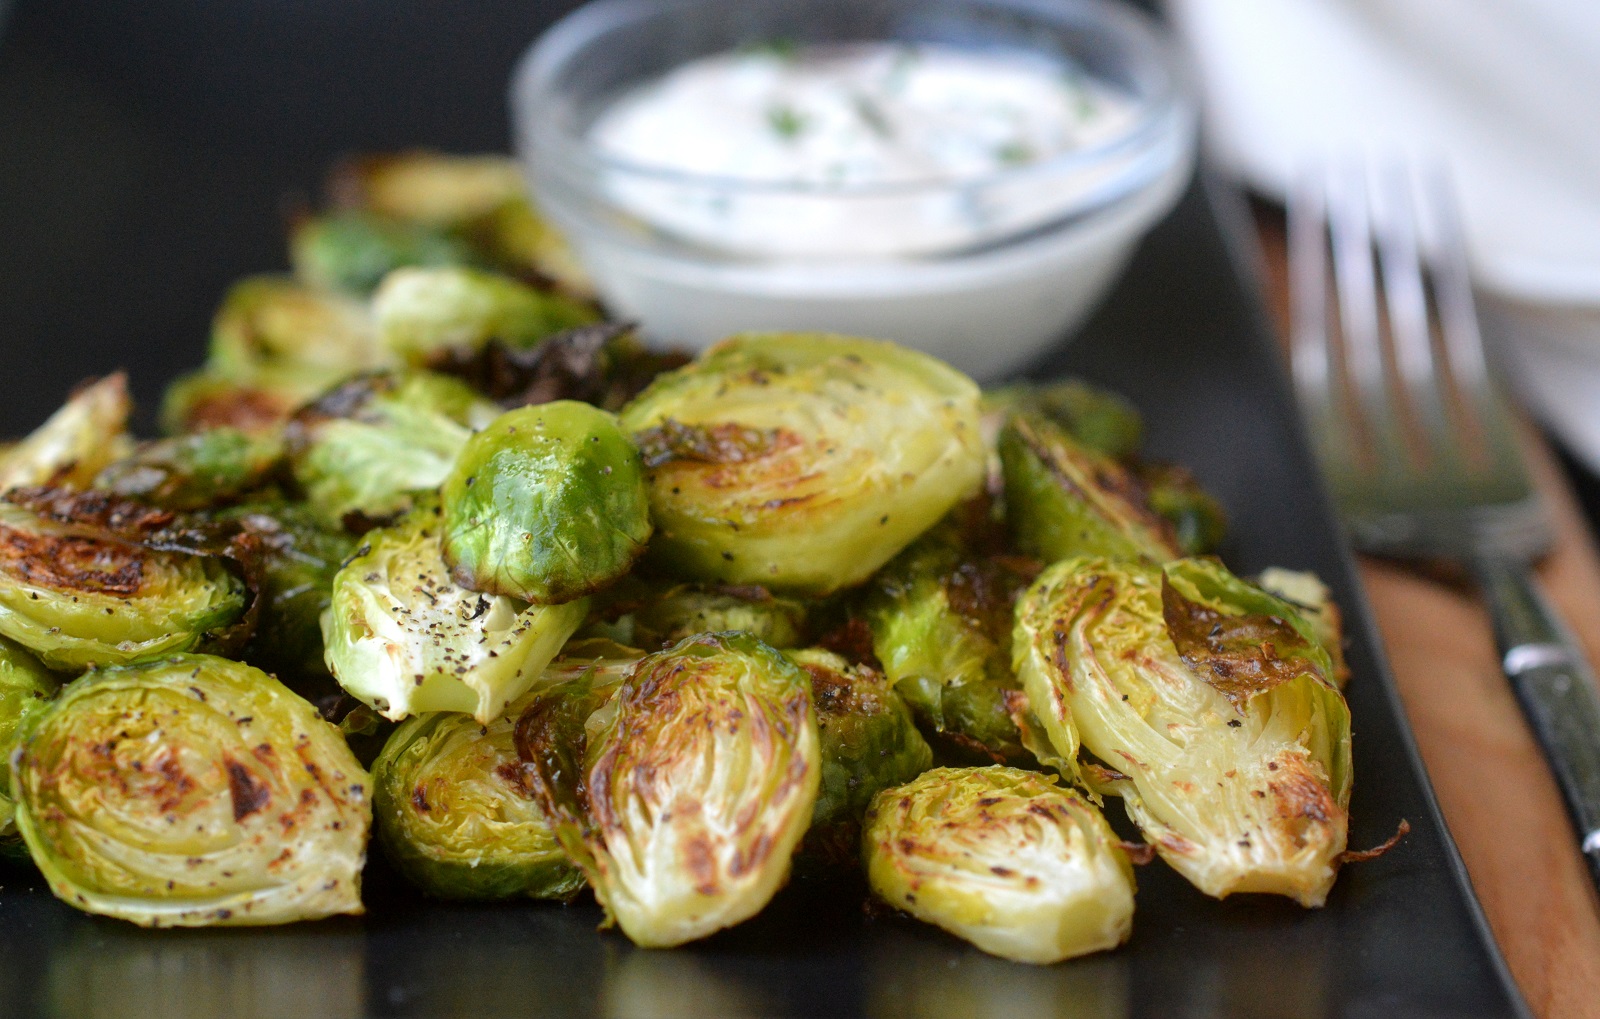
[622,333,986,593]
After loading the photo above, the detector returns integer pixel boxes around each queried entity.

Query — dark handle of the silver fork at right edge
[1474,558,1600,886]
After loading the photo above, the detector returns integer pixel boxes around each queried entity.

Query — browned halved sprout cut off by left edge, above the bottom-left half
[0,504,248,670]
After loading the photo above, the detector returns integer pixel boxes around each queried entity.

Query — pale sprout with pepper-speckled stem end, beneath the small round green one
[322,506,589,725]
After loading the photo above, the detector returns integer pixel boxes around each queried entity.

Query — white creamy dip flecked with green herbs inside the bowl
[589,42,1138,259]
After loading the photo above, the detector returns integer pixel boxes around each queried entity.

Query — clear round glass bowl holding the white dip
[510,0,1195,378]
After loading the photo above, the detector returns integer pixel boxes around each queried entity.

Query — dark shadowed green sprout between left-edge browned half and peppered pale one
[222,502,357,693]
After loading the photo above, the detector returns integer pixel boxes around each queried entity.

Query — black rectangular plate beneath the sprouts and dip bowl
[0,0,1526,1019]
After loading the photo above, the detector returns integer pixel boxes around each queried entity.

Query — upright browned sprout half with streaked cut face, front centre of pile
[517,632,821,947]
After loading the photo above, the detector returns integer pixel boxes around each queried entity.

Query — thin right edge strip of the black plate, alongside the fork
[1200,158,1533,1019]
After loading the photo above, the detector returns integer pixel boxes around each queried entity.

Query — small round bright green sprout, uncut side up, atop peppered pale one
[442,400,650,605]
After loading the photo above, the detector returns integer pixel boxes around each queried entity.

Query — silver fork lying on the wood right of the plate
[1288,162,1600,885]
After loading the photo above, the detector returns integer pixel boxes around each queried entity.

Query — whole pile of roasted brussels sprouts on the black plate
[0,154,1350,963]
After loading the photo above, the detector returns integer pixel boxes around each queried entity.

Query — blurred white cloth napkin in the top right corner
[1168,0,1600,469]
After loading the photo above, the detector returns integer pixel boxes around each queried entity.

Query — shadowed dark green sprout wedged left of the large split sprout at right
[864,521,1038,765]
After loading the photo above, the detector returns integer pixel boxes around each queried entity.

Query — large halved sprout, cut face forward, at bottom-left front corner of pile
[13,654,371,926]
